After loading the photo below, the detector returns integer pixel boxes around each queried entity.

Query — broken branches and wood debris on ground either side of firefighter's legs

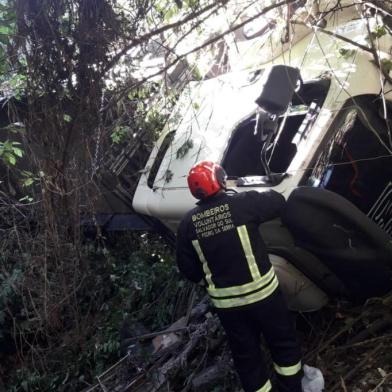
[88,293,392,392]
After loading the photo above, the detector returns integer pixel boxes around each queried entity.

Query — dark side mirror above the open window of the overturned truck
[256,65,302,116]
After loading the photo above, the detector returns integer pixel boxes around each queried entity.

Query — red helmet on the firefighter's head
[188,161,227,199]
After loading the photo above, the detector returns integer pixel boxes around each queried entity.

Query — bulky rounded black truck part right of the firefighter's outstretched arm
[282,187,392,300]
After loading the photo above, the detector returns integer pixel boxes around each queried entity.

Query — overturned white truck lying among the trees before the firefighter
[133,4,392,311]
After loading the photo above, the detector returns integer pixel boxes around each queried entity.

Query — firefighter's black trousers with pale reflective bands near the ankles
[217,289,302,392]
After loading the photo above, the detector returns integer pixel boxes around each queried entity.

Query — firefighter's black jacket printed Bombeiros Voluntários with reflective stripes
[177,191,285,307]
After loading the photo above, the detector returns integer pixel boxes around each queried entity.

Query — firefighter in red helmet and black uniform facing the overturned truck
[177,161,302,392]
